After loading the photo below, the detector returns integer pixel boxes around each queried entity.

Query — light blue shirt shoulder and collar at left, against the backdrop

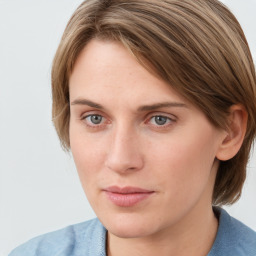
[9,219,106,256]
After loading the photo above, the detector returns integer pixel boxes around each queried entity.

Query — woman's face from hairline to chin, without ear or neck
[70,40,224,237]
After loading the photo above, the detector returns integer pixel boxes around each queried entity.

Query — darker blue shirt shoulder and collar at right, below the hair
[208,208,256,256]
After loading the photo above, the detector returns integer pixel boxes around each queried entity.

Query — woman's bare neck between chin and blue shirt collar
[107,205,218,256]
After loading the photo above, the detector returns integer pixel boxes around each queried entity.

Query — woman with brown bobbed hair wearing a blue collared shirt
[10,0,256,256]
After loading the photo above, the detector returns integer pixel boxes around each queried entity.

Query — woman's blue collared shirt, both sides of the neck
[9,208,256,256]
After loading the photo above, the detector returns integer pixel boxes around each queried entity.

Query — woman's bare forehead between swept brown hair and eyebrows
[69,40,189,108]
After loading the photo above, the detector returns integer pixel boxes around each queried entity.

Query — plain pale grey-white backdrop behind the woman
[0,0,256,256]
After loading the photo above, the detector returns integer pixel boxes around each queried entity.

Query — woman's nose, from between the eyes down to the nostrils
[106,126,144,174]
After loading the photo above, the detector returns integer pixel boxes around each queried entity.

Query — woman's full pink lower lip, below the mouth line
[105,191,154,207]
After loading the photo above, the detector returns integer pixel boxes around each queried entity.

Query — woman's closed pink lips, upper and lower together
[103,186,154,207]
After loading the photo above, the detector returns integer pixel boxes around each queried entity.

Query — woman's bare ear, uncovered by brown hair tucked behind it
[216,104,248,161]
